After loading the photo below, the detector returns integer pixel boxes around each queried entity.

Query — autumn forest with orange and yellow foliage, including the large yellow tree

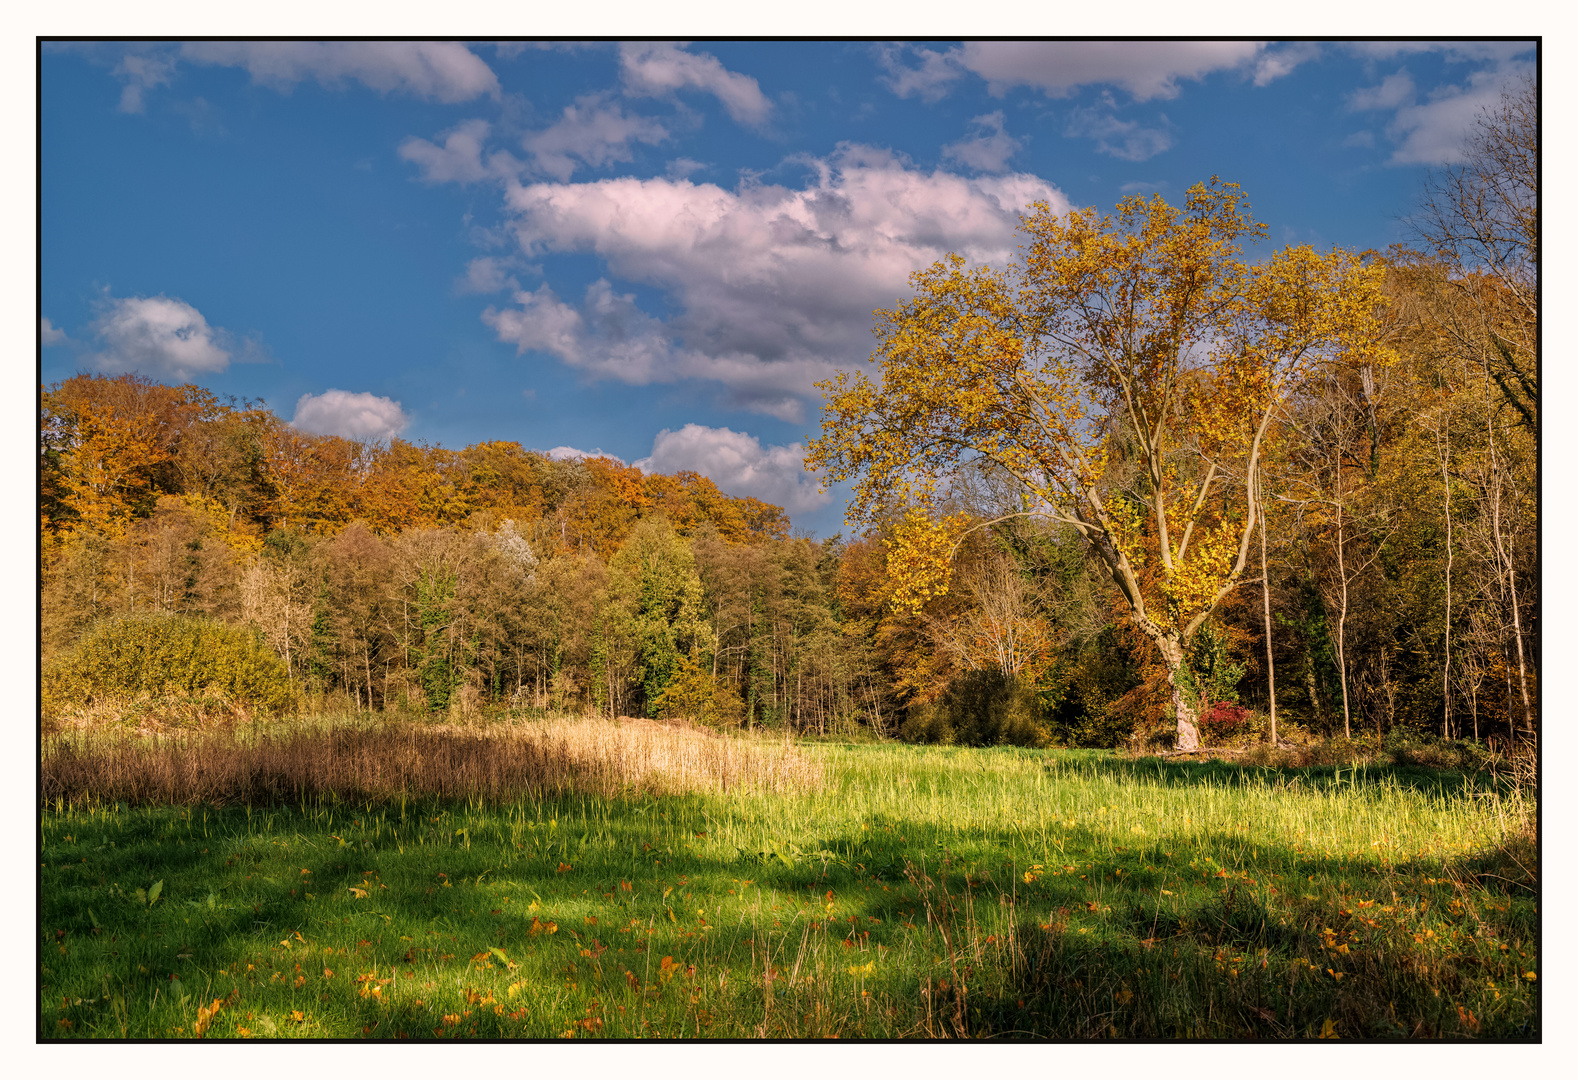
[39,87,1540,747]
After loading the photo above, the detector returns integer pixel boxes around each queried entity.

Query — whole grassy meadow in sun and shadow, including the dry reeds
[38,722,1542,1041]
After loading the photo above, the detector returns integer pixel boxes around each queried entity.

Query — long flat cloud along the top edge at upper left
[181,41,499,104]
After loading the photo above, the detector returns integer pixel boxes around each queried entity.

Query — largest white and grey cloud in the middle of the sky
[483,145,1068,420]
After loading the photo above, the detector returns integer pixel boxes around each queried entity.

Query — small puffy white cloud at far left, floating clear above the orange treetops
[92,295,230,381]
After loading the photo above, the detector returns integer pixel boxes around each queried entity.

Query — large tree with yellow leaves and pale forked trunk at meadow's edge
[806,178,1389,750]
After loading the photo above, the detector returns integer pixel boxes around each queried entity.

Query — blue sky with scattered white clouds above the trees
[41,41,1534,535]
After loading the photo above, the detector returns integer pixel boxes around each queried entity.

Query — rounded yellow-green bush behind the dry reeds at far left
[39,614,290,720]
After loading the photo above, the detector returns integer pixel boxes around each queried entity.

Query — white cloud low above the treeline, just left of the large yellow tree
[636,423,832,515]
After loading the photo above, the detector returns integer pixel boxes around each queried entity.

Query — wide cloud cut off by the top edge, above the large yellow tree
[879,41,1262,101]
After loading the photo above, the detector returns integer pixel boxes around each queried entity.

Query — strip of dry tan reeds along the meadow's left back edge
[41,718,822,805]
